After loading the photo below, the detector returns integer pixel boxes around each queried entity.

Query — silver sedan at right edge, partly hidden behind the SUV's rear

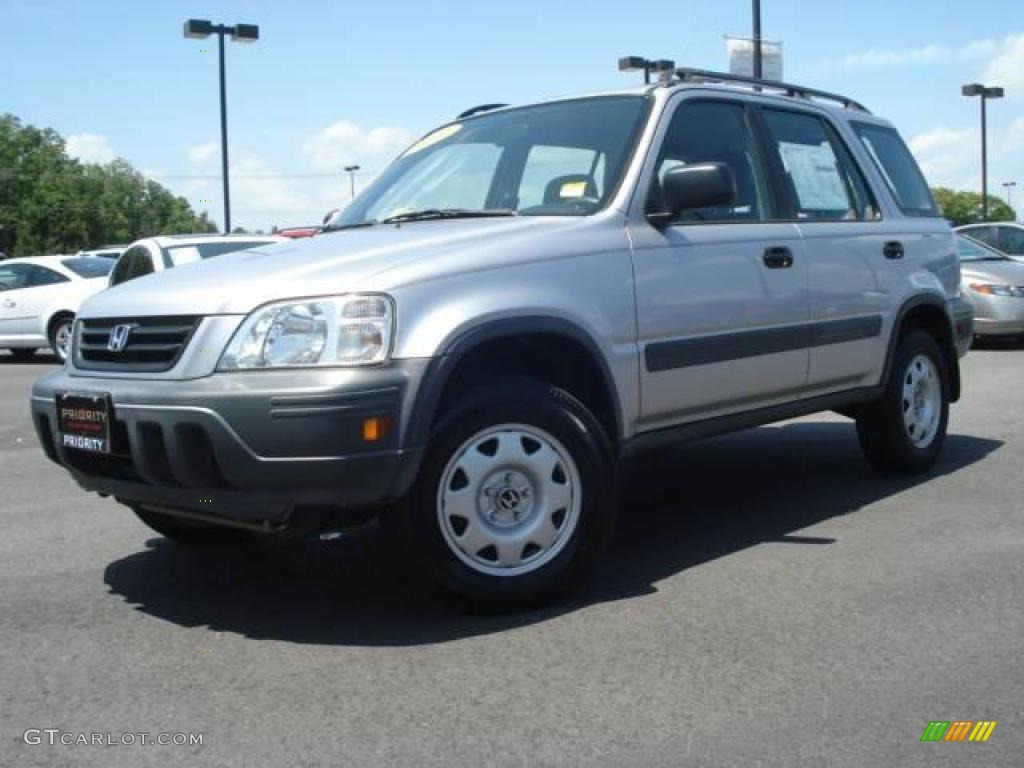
[956,234,1024,338]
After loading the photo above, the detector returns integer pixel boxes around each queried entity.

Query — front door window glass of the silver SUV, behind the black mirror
[649,101,767,221]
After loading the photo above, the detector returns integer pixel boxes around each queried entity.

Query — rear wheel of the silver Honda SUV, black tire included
[857,330,949,474]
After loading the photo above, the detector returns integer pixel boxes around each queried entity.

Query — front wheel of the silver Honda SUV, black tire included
[394,379,616,605]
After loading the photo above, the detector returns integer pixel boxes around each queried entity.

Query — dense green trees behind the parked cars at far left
[0,115,216,256]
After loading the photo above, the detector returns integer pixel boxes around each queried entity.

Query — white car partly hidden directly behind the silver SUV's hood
[110,234,289,288]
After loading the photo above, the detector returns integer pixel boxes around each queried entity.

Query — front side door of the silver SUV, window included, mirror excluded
[629,98,808,429]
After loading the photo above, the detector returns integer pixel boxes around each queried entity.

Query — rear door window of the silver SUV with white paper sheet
[764,110,878,221]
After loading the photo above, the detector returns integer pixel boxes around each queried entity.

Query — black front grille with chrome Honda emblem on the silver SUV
[73,315,201,372]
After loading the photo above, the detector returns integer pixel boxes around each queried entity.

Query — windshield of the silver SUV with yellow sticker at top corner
[328,96,646,228]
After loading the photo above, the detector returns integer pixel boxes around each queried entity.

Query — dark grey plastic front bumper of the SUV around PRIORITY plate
[32,359,429,524]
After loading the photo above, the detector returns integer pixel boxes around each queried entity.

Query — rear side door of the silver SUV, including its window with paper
[761,108,902,396]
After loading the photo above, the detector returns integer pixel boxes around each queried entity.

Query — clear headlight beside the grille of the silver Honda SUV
[217,294,394,371]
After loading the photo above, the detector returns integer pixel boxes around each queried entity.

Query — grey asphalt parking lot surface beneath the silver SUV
[0,344,1024,768]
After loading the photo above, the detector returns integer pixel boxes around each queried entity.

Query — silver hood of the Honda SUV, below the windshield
[80,216,586,317]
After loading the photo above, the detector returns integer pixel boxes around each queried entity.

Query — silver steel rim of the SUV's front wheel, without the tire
[437,424,582,577]
